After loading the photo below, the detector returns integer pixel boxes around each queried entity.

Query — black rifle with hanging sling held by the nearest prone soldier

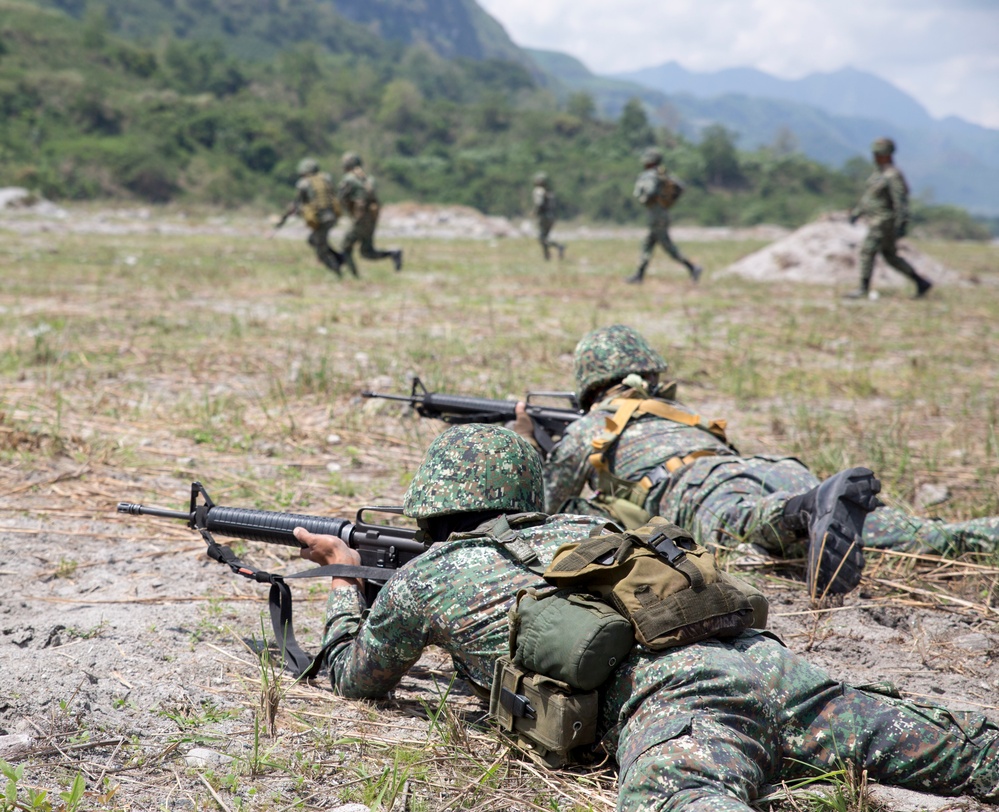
[118,482,427,678]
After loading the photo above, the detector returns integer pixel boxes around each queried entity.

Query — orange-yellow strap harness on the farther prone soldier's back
[576,390,729,529]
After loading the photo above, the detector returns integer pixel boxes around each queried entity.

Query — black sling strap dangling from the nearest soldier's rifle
[198,528,392,679]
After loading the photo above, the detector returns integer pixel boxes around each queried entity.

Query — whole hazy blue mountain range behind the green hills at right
[540,50,999,216]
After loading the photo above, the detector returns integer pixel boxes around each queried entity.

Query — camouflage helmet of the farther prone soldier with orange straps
[573,324,668,409]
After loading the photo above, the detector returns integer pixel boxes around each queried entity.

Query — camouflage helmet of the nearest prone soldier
[402,423,545,519]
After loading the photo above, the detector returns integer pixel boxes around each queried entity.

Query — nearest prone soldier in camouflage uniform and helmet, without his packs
[295,425,999,812]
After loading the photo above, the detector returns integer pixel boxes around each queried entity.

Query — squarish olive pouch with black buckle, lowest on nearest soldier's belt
[489,657,598,769]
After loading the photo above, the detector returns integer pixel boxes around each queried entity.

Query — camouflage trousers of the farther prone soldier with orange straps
[658,456,999,555]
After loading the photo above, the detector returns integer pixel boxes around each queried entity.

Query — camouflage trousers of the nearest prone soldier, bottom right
[604,633,999,812]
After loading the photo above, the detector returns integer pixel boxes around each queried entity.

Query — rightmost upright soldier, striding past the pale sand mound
[846,138,933,299]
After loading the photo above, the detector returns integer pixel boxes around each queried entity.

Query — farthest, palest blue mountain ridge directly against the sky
[614,62,933,127]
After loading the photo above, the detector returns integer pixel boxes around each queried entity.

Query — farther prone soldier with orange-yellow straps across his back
[514,325,999,596]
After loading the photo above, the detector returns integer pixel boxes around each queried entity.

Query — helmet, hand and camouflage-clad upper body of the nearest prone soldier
[295,424,606,698]
